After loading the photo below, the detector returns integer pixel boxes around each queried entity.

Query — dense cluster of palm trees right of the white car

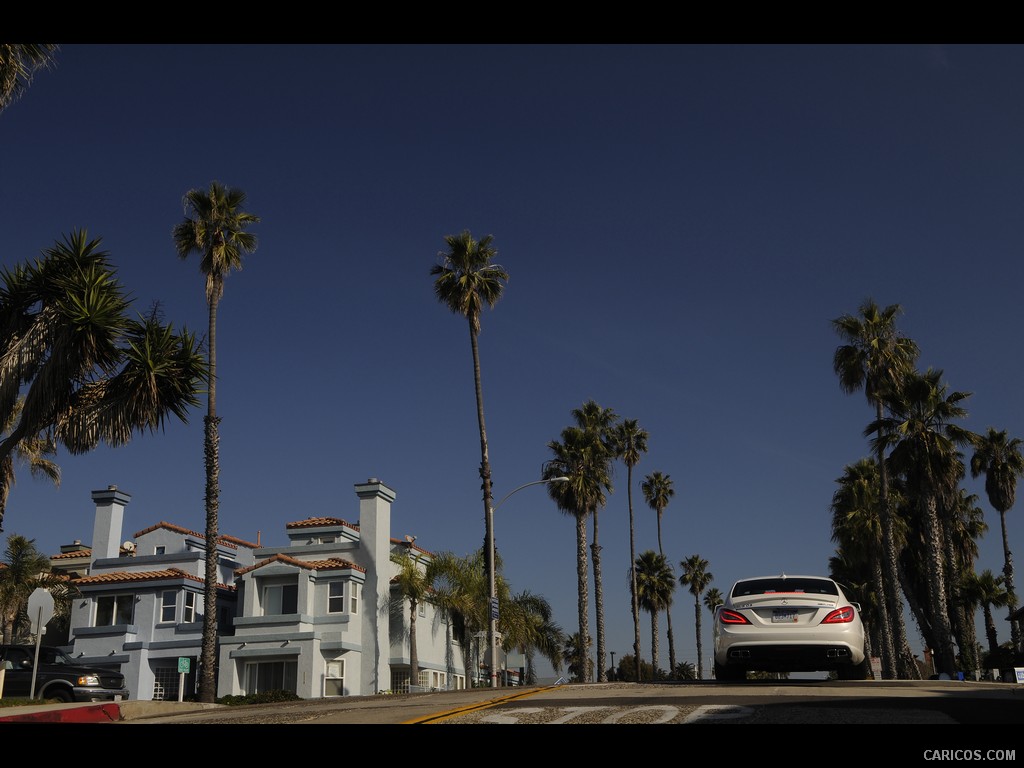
[830,299,1024,679]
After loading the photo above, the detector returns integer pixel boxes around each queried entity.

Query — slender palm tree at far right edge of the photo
[971,427,1024,650]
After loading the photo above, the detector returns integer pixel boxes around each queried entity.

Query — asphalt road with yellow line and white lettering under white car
[116,681,1024,729]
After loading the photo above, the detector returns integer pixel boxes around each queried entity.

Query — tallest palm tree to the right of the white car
[831,299,920,679]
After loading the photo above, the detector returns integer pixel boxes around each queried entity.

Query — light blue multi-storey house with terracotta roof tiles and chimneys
[58,478,466,700]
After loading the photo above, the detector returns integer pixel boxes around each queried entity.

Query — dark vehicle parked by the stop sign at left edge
[0,645,129,701]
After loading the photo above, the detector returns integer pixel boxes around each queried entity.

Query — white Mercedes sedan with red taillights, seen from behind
[712,573,867,681]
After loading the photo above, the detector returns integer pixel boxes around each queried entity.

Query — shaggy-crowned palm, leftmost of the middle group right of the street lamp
[542,426,610,682]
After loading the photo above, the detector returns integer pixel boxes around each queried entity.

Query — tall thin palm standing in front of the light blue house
[172,181,259,702]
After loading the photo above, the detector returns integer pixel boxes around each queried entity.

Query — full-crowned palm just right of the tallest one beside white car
[865,369,972,675]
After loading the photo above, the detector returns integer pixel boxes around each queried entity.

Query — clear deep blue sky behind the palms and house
[0,44,1024,676]
